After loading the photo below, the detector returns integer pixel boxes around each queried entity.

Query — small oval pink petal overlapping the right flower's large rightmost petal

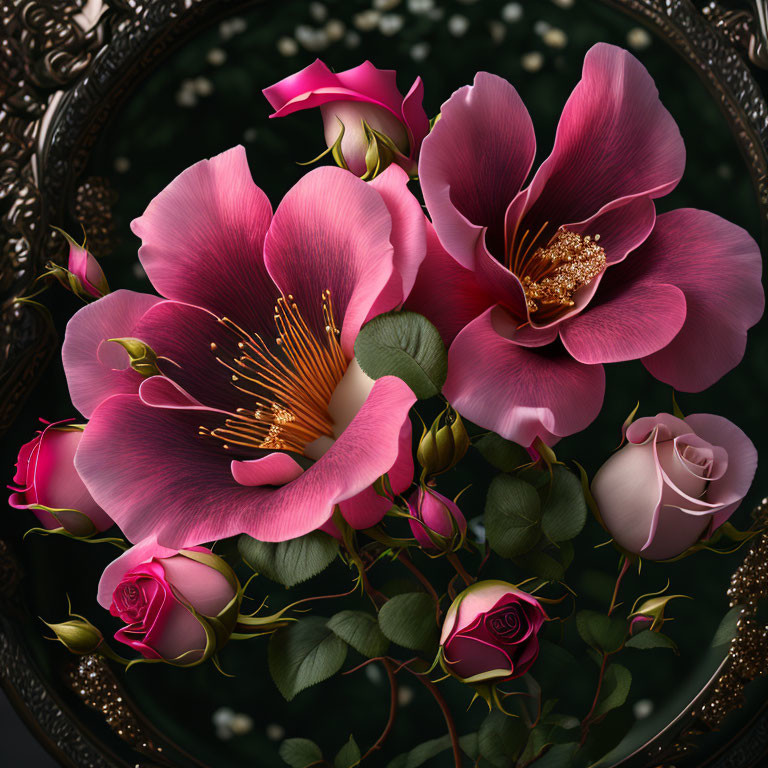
[560,282,685,365]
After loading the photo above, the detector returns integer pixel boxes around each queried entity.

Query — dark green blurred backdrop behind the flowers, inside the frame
[3,0,768,768]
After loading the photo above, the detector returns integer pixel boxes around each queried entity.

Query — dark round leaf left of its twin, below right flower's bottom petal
[485,475,541,558]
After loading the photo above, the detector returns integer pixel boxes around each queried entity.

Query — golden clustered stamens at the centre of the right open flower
[507,222,605,322]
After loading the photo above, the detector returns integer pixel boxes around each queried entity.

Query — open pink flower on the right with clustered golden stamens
[408,43,764,446]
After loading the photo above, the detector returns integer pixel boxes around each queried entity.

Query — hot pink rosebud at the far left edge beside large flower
[8,424,112,536]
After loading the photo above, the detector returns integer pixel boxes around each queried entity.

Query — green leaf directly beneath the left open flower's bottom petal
[237,531,339,587]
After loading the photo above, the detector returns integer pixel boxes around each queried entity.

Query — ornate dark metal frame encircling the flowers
[0,0,768,768]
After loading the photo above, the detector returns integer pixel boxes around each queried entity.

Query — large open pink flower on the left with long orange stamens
[63,147,424,549]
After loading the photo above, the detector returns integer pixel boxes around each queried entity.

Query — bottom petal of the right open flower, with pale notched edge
[443,307,605,446]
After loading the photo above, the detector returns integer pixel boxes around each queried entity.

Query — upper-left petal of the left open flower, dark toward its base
[131,146,275,323]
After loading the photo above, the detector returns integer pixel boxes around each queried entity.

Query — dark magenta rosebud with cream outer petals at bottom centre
[440,581,547,683]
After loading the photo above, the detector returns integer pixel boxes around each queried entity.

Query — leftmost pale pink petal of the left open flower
[61,290,160,417]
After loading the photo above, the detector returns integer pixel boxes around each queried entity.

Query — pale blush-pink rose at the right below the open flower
[592,413,757,560]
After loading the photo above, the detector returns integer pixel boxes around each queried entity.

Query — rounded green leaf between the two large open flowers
[355,312,448,400]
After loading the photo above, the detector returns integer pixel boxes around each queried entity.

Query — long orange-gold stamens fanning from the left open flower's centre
[199,291,348,454]
